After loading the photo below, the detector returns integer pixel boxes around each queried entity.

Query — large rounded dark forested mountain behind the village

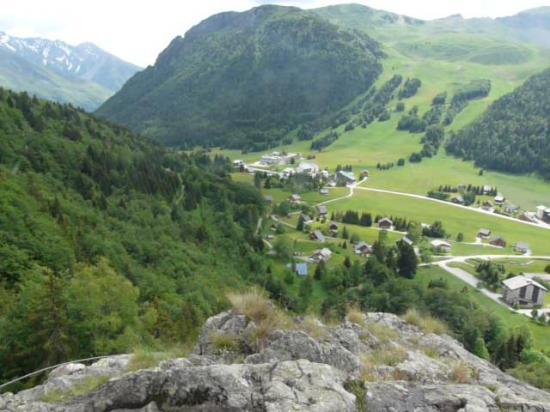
[97,6,382,150]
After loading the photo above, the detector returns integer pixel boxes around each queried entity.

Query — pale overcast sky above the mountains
[0,0,550,66]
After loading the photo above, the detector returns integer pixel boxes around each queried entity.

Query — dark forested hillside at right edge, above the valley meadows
[447,69,550,179]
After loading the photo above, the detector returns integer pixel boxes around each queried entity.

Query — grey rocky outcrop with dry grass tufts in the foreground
[0,312,550,412]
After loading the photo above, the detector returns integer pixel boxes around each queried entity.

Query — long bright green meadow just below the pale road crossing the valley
[328,190,550,255]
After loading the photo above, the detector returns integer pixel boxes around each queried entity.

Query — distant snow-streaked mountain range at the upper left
[0,32,140,110]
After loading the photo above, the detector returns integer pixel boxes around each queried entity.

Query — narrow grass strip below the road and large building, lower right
[415,267,550,350]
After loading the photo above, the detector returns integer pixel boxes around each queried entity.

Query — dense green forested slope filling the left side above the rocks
[0,89,265,381]
